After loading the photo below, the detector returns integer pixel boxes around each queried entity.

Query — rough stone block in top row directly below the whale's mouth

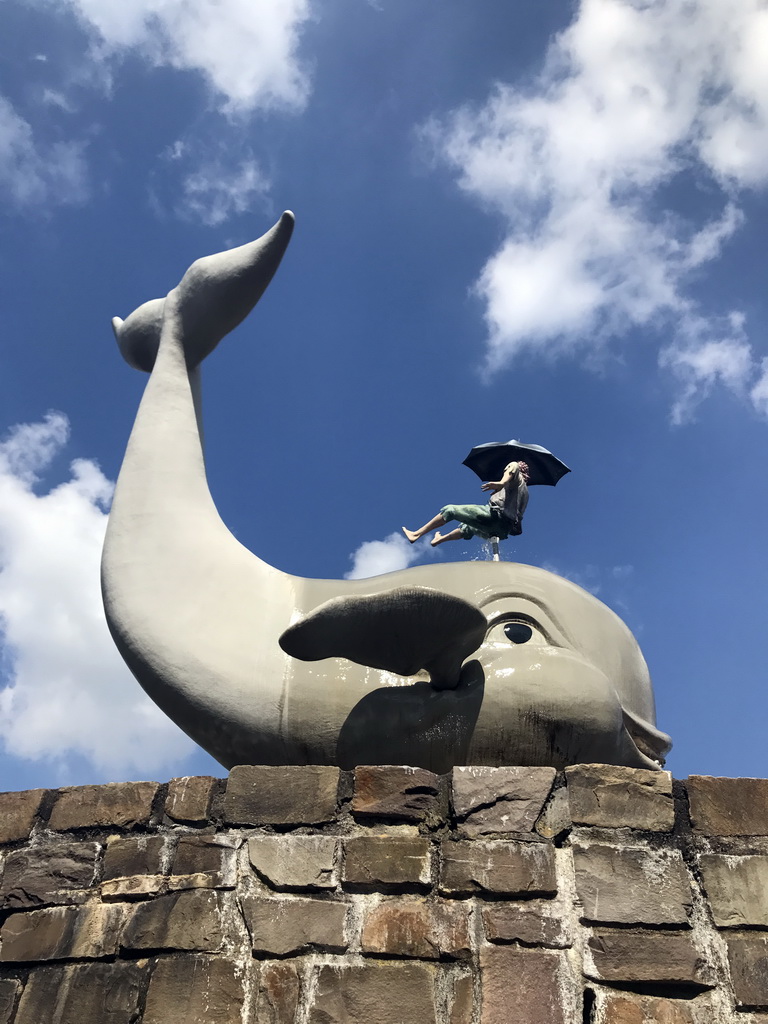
[565,765,675,831]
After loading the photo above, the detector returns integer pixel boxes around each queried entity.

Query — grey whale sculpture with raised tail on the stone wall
[102,213,671,772]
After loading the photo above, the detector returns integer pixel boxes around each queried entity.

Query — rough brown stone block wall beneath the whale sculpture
[0,765,768,1024]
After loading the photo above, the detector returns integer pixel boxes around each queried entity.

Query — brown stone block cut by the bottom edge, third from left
[141,956,243,1024]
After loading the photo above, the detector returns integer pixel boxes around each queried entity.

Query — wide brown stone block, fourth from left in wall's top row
[224,765,340,825]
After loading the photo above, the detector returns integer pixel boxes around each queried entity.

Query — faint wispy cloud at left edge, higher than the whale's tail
[0,96,88,209]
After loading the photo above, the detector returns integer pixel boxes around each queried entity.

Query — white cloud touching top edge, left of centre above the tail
[57,0,310,111]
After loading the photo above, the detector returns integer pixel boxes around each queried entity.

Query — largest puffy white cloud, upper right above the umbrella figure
[425,0,768,415]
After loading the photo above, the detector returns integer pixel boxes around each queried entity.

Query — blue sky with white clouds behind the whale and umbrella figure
[0,0,768,790]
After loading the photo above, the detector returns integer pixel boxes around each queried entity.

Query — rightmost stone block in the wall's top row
[686,775,768,836]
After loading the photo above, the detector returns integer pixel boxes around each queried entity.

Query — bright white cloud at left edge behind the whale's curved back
[0,413,194,776]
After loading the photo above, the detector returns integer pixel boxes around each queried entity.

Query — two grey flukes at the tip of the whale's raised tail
[112,211,294,373]
